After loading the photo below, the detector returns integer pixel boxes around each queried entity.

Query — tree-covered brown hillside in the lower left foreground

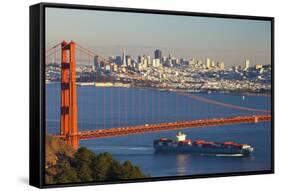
[45,135,147,184]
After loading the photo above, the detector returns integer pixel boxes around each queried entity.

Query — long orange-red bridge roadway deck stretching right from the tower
[56,115,271,140]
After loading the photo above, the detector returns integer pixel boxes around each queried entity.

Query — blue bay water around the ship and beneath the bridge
[46,84,271,177]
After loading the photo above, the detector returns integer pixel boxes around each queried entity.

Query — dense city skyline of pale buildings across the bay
[46,49,271,93]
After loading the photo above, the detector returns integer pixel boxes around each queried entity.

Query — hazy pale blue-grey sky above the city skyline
[46,8,271,66]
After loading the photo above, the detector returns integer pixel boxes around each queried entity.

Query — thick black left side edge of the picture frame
[29,4,45,188]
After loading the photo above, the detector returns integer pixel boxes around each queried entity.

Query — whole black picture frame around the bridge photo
[29,3,274,188]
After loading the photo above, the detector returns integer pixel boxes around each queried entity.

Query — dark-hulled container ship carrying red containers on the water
[153,132,254,155]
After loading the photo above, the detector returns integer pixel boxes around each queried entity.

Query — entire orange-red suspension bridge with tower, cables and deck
[46,41,271,149]
